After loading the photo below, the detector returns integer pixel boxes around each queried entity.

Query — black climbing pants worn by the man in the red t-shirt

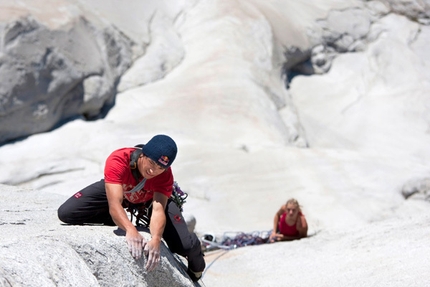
[58,180,205,272]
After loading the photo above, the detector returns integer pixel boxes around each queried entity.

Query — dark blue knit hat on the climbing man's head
[142,135,178,168]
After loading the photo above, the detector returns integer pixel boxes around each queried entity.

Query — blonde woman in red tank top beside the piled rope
[269,198,308,242]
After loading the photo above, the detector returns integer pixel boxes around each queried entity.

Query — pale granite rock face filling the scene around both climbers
[0,0,430,286]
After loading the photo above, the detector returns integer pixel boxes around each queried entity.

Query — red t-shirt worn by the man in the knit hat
[104,148,173,203]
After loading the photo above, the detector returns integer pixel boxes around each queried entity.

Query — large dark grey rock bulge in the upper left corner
[0,2,132,142]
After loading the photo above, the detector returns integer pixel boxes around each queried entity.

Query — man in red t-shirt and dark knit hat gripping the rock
[58,135,205,281]
